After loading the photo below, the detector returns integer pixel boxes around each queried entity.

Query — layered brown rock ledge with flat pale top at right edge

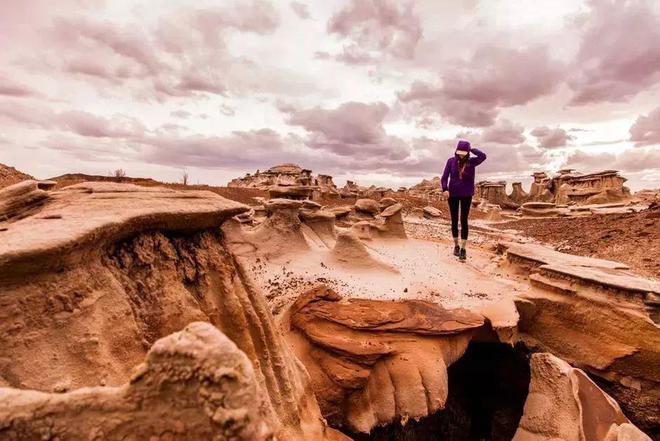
[501,243,660,431]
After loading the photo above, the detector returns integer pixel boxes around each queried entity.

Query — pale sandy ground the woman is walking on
[240,215,528,315]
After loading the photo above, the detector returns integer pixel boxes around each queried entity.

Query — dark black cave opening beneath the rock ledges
[347,342,530,441]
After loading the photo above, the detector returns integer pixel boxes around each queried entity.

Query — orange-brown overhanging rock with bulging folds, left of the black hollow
[287,287,484,433]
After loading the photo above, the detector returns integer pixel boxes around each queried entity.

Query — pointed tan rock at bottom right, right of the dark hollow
[513,353,651,441]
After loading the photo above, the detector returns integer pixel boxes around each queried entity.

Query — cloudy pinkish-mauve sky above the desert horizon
[0,0,660,189]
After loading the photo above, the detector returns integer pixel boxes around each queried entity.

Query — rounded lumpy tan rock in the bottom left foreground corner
[0,322,277,441]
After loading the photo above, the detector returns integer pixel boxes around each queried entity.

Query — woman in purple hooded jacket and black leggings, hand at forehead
[441,140,486,260]
